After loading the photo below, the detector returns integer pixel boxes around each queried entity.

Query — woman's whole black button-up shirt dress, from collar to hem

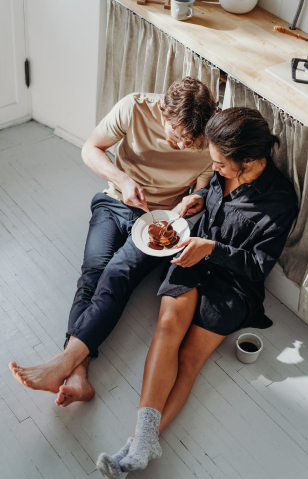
[158,160,298,335]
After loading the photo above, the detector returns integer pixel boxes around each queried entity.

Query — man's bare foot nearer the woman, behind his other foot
[56,358,95,407]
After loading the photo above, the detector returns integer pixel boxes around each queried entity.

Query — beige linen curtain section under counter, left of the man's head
[99,0,219,119]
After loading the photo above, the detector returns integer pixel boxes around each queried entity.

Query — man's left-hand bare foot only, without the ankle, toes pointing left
[9,353,71,393]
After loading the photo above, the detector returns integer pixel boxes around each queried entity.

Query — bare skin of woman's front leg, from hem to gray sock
[139,288,198,413]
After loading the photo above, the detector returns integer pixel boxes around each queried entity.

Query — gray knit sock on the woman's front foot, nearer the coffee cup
[119,407,162,472]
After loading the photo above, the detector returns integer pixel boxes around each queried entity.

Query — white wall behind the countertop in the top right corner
[258,0,308,33]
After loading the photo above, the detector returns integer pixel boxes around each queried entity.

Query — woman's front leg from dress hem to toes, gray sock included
[116,288,198,477]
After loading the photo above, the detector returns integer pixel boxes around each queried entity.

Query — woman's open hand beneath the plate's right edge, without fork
[171,238,215,268]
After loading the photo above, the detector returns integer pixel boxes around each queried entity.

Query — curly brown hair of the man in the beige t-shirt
[160,77,217,150]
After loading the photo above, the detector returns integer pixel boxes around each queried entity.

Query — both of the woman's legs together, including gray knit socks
[98,289,224,478]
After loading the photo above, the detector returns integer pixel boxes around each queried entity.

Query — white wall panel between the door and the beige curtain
[26,0,107,144]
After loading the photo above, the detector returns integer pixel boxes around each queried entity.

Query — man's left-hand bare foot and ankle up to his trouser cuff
[9,336,89,393]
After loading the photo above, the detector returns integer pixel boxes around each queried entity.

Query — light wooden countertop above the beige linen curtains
[117,0,308,125]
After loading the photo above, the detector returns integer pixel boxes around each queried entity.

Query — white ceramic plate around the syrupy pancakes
[132,210,190,256]
